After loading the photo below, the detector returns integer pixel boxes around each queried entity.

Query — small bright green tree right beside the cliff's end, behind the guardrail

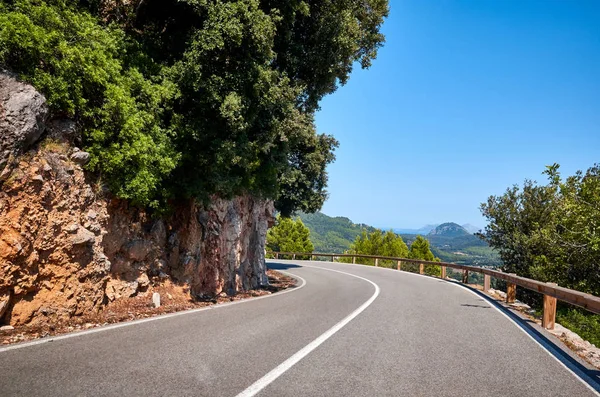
[267,216,314,255]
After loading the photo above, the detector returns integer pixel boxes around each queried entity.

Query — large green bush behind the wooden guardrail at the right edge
[481,164,600,343]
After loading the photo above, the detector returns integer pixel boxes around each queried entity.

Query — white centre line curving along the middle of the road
[237,266,379,397]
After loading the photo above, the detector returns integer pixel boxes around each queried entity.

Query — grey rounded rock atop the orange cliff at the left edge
[0,70,48,180]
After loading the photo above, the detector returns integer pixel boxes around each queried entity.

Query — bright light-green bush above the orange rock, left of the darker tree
[0,0,180,207]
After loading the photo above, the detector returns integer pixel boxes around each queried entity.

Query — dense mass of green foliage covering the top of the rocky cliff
[0,0,388,215]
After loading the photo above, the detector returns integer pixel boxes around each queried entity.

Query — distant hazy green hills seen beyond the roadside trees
[298,212,501,266]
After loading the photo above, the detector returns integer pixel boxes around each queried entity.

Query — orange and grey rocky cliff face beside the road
[0,72,274,325]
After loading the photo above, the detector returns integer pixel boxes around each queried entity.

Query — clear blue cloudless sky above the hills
[316,0,600,228]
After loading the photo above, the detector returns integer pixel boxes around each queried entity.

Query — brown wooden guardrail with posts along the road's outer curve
[267,252,600,329]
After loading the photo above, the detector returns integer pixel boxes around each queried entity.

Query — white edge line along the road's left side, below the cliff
[0,270,306,353]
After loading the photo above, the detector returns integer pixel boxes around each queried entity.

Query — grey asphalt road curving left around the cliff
[0,261,598,397]
